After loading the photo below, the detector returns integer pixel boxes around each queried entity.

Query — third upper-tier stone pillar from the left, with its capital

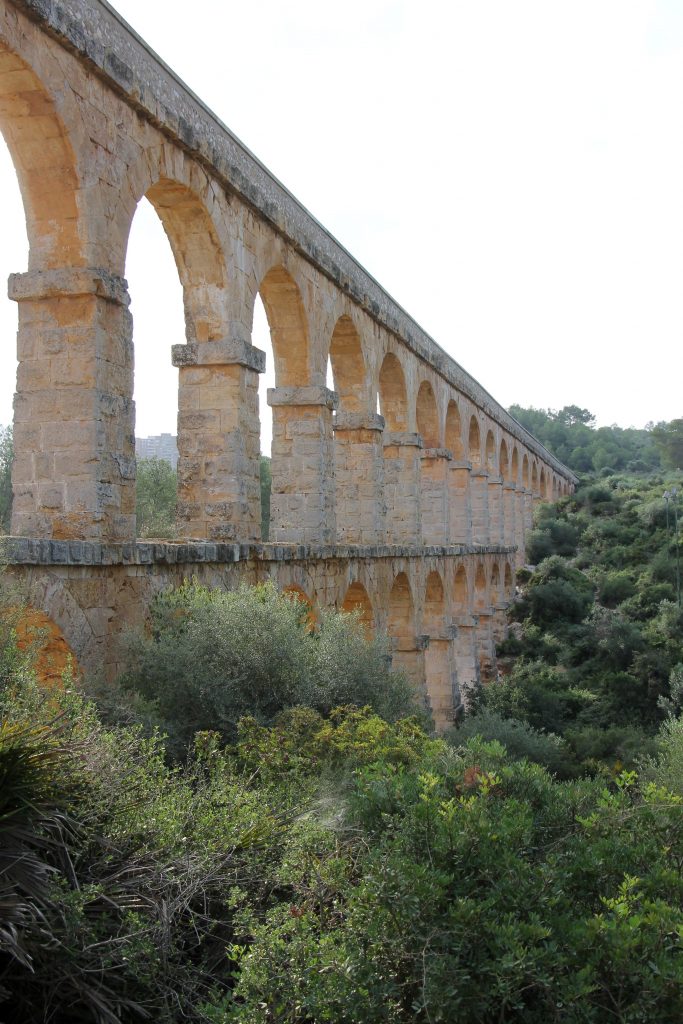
[268,386,337,544]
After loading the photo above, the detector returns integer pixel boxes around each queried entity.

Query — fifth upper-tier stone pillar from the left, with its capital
[384,431,422,545]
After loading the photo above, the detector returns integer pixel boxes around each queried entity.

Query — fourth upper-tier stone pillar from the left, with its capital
[333,412,386,545]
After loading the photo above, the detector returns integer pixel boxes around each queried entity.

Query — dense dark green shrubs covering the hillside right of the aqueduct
[465,474,683,773]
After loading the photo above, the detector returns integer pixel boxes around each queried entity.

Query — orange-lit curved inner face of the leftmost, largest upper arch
[0,42,87,269]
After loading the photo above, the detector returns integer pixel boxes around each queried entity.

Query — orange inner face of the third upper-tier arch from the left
[258,266,310,387]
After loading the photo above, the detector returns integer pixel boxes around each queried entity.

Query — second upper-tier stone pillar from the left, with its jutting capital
[173,337,265,542]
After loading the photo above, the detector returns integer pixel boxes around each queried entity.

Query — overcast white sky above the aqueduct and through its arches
[0,0,683,435]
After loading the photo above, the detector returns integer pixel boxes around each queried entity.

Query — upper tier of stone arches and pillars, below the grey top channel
[0,6,570,546]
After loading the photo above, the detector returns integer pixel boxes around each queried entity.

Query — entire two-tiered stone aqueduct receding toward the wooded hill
[0,0,574,725]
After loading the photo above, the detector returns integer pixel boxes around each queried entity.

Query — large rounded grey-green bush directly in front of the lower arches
[121,584,417,755]
